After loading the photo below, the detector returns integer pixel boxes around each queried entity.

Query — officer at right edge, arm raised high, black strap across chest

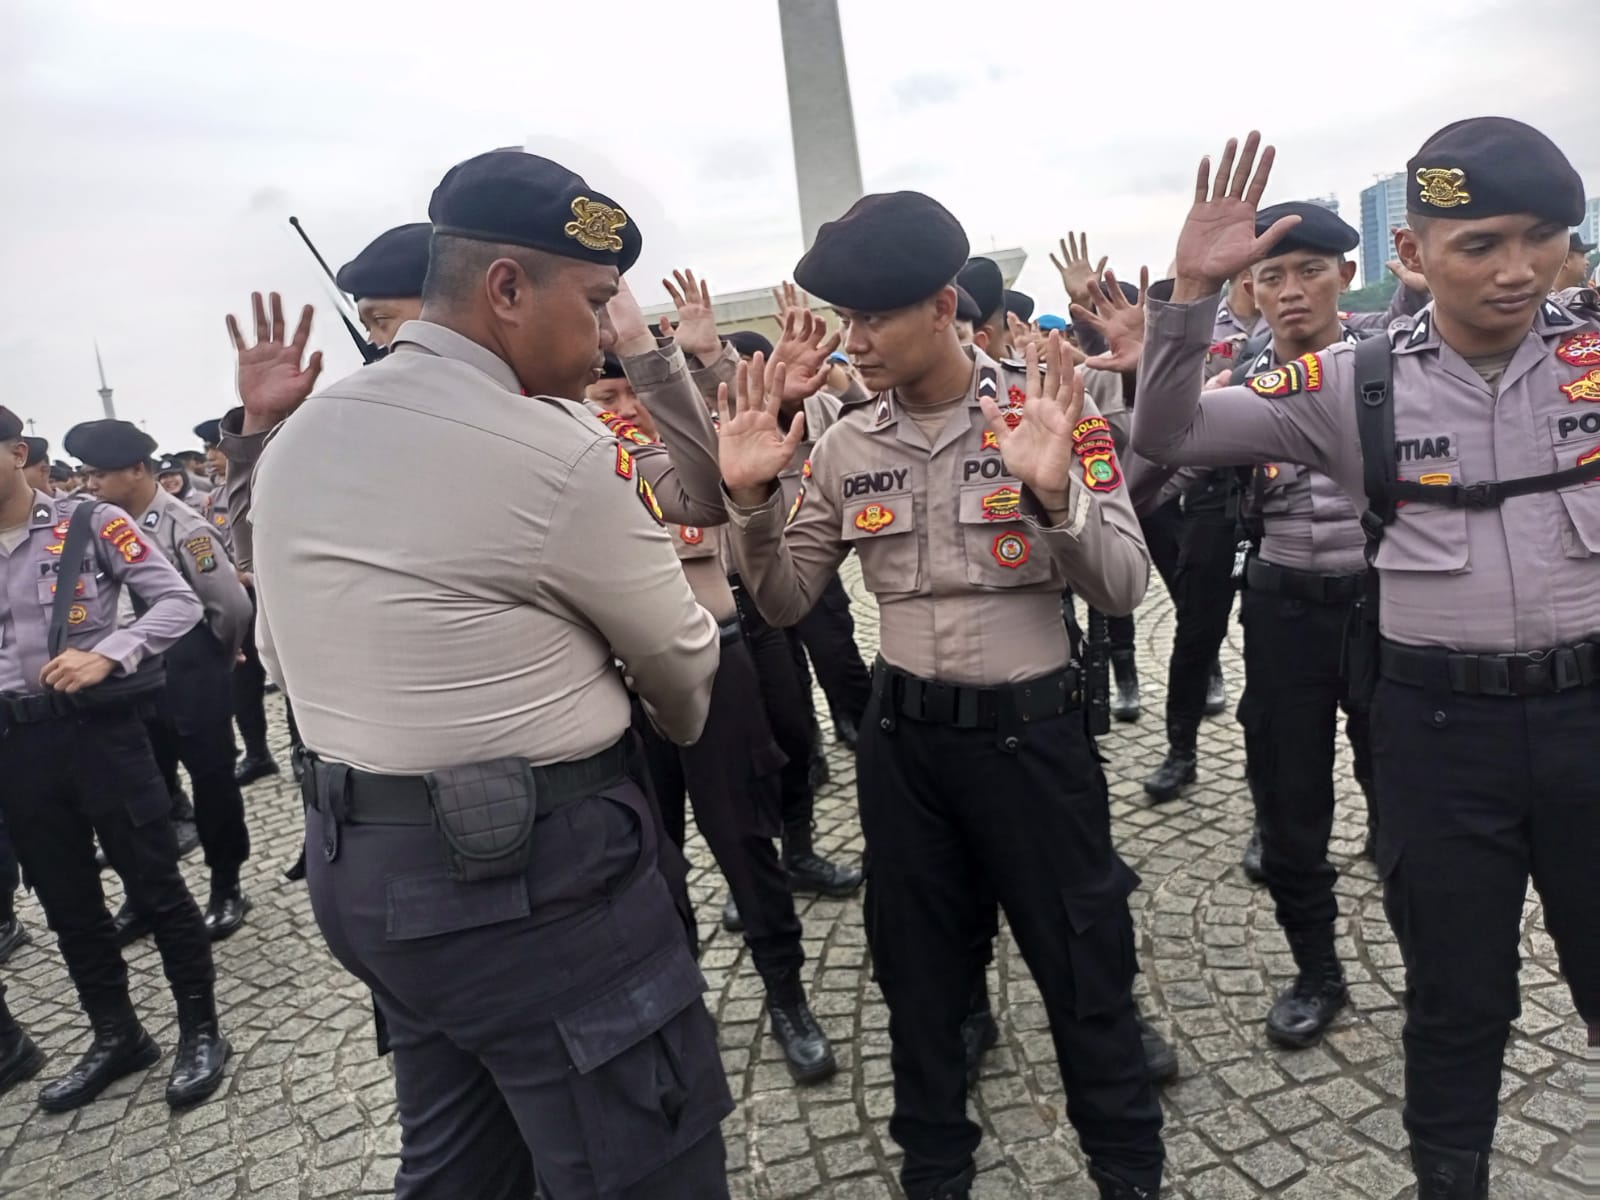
[1134,117,1600,1200]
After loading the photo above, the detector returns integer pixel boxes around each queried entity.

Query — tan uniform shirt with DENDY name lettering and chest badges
[728,350,1149,686]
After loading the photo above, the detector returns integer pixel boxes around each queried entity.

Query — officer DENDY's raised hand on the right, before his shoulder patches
[979,330,1083,512]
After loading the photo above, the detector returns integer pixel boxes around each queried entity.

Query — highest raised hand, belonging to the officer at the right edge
[1173,131,1299,301]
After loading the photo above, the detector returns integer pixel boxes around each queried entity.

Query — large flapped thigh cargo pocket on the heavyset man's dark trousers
[555,946,733,1197]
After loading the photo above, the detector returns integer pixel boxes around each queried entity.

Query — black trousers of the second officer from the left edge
[149,626,250,888]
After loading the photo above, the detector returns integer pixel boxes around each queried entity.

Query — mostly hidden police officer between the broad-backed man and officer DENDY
[589,286,838,1083]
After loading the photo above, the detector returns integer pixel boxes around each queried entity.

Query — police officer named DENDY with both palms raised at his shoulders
[720,192,1163,1200]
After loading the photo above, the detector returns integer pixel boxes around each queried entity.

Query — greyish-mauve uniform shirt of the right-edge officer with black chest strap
[1133,293,1600,653]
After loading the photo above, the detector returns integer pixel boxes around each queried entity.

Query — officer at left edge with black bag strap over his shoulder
[0,410,229,1112]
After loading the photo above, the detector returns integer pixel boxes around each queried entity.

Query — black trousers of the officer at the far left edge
[0,710,214,1014]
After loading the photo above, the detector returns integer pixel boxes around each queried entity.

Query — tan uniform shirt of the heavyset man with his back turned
[251,322,718,774]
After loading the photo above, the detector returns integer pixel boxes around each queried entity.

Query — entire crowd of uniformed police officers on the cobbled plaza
[0,117,1600,1200]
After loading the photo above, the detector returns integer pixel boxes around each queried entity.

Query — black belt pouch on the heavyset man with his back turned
[424,758,538,883]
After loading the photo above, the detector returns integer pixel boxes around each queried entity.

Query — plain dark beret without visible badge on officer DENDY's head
[794,192,968,312]
